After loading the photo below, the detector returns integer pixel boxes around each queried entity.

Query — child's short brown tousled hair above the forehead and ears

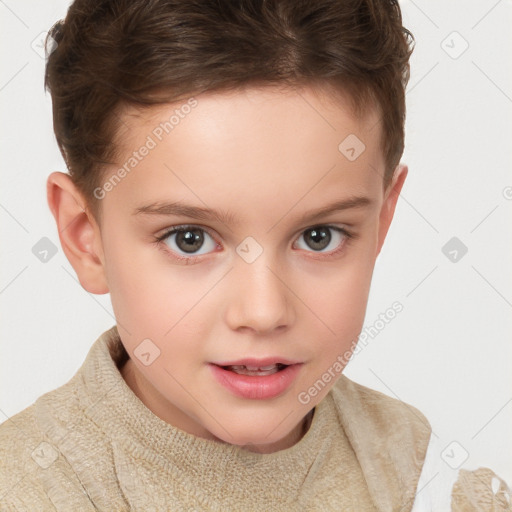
[45,0,414,224]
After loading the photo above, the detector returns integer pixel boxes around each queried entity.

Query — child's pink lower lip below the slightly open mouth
[209,363,302,400]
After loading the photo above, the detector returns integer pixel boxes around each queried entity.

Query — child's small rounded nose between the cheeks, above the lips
[226,252,295,334]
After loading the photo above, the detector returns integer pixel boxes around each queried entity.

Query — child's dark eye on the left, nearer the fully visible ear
[156,226,217,259]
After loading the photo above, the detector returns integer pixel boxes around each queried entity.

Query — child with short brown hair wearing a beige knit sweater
[0,0,512,512]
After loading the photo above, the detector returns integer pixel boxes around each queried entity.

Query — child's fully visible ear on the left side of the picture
[46,172,109,294]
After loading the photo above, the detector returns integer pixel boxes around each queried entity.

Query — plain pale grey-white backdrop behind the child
[0,0,512,484]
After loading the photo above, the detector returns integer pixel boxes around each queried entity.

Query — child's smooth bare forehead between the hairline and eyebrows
[106,86,384,218]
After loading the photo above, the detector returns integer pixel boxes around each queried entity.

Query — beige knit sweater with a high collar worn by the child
[0,326,510,512]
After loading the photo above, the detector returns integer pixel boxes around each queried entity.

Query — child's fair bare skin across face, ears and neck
[47,86,407,453]
